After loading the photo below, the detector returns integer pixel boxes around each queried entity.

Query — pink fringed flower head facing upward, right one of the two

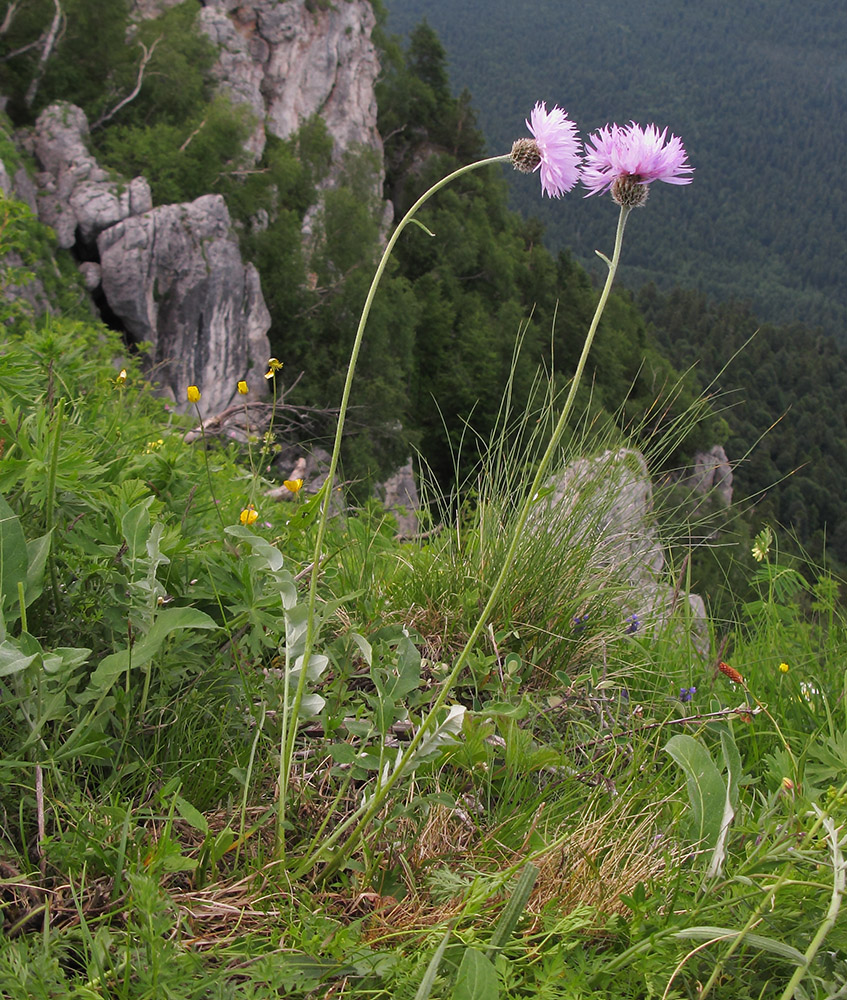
[582,122,694,204]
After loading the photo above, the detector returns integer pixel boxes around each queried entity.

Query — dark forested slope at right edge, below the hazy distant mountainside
[637,286,847,565]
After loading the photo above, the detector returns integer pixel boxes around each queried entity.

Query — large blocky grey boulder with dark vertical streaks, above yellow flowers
[97,195,270,413]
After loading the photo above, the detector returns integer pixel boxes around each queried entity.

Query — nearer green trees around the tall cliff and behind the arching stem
[0,0,713,493]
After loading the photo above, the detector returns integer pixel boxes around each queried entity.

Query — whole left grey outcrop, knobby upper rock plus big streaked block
[25,104,270,413]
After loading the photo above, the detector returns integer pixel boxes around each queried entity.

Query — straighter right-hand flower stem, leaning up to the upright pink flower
[296,205,631,876]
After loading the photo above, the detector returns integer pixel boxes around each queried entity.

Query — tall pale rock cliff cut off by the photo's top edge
[198,0,382,182]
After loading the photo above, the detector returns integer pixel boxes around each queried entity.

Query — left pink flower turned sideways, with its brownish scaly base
[512,101,582,198]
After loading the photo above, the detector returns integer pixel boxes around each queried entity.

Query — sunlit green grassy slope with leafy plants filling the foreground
[0,213,847,1000]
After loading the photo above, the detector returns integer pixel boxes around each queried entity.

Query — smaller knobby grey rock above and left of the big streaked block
[32,103,153,250]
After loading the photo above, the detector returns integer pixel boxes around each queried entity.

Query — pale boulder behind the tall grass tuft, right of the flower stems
[532,448,709,655]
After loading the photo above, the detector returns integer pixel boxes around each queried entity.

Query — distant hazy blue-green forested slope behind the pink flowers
[387,0,847,340]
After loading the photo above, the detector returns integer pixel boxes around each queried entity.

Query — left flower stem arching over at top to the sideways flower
[277,153,512,856]
